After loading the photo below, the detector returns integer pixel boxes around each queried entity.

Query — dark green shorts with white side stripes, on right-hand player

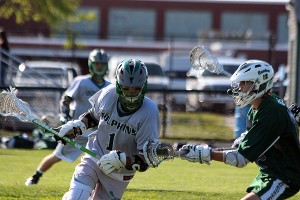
[247,173,299,200]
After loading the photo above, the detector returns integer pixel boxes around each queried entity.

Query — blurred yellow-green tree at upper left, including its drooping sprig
[0,0,96,51]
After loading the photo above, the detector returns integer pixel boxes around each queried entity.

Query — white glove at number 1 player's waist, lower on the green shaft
[97,150,126,175]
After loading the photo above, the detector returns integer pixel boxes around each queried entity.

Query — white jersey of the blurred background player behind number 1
[65,75,110,119]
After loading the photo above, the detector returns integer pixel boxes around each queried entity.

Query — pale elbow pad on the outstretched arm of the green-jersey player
[223,150,249,168]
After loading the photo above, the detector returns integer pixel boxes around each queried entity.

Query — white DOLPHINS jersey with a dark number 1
[86,84,160,177]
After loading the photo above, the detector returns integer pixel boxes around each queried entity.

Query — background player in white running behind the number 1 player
[25,49,110,186]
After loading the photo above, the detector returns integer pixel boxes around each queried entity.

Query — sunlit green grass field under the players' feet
[0,149,300,200]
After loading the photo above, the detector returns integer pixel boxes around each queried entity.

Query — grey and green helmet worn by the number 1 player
[116,59,148,111]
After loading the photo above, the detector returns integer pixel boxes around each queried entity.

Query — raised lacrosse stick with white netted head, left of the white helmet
[190,46,232,77]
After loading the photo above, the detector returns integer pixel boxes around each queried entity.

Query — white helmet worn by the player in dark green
[230,60,274,108]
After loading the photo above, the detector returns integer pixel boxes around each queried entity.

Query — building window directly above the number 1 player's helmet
[108,8,156,40]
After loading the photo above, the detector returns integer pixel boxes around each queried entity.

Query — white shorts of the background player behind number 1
[53,128,96,162]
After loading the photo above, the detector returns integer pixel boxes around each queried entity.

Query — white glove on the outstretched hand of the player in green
[179,144,211,165]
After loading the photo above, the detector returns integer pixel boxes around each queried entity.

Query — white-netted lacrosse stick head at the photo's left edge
[0,87,32,121]
